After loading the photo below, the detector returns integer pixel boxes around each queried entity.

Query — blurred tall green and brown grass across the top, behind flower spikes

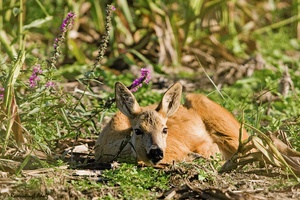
[0,0,300,79]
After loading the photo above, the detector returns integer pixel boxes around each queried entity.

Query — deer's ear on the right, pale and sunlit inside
[156,82,182,117]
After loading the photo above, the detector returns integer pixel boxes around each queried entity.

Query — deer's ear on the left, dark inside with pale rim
[115,82,141,118]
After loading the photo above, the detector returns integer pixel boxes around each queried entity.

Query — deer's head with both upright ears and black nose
[115,82,182,165]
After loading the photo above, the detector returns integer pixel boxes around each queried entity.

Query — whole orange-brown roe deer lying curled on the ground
[95,83,248,165]
